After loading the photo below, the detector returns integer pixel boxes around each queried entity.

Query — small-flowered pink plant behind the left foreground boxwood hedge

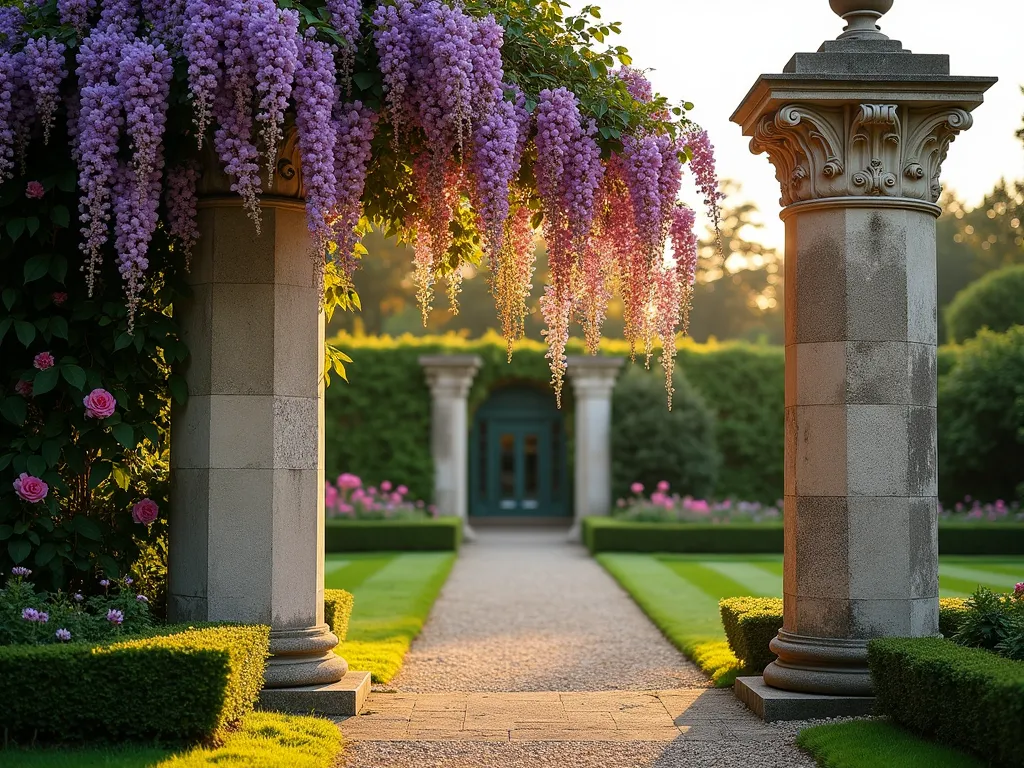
[0,565,154,645]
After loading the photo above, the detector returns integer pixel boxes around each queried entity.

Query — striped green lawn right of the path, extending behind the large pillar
[597,553,1024,687]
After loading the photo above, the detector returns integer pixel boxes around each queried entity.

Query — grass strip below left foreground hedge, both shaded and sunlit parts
[0,712,342,768]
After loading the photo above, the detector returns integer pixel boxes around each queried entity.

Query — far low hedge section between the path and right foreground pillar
[583,517,782,554]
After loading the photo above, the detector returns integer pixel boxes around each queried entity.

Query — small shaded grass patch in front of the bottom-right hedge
[797,720,984,768]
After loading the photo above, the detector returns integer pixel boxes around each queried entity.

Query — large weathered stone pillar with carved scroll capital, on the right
[732,0,995,695]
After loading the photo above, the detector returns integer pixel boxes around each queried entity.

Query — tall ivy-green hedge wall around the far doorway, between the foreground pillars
[326,335,784,502]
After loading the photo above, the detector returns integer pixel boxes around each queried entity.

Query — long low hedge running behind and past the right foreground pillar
[583,517,1024,555]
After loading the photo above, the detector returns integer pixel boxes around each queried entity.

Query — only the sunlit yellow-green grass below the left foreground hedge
[156,712,342,768]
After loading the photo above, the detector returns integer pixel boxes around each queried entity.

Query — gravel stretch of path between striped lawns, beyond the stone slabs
[391,528,708,693]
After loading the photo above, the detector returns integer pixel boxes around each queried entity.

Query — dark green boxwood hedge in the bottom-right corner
[867,638,1024,768]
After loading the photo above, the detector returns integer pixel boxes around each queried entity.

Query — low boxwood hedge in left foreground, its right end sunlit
[0,625,269,742]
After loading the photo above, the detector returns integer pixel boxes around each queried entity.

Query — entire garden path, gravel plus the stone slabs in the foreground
[339,529,815,768]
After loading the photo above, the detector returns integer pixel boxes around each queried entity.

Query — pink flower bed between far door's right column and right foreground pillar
[612,480,782,524]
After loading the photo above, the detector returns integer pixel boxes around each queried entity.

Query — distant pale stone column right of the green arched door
[568,356,623,542]
